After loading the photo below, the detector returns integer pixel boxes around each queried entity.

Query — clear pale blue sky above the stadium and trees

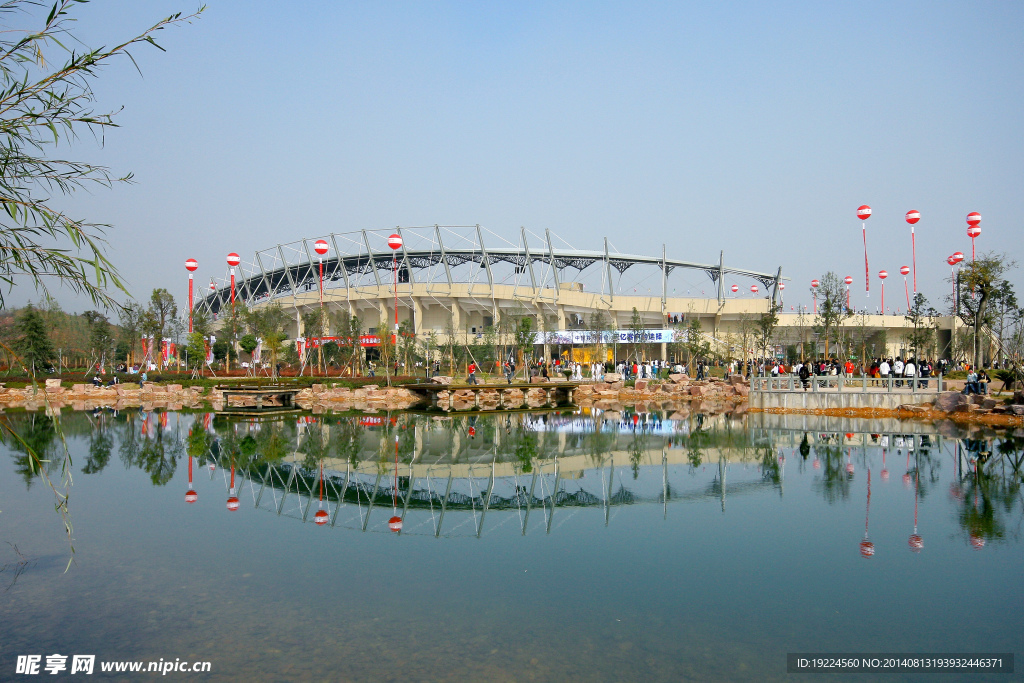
[18,0,1024,310]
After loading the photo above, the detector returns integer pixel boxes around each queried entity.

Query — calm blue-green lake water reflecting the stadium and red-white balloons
[0,411,1024,681]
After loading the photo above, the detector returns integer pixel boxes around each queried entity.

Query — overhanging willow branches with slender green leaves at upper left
[0,0,202,307]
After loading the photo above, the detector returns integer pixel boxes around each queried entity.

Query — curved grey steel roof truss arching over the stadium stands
[197,225,782,315]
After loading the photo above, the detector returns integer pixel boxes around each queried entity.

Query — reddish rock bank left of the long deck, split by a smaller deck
[0,380,419,413]
